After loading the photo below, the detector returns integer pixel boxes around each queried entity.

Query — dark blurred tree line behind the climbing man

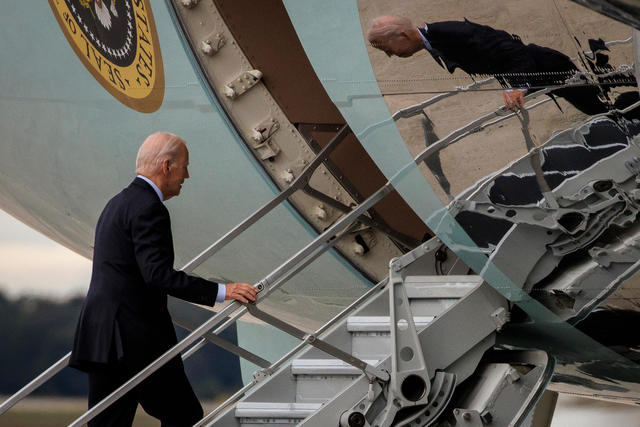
[0,292,242,399]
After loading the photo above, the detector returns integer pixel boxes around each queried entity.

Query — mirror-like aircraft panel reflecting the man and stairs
[285,1,640,400]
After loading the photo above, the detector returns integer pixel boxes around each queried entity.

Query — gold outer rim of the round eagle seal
[49,0,164,113]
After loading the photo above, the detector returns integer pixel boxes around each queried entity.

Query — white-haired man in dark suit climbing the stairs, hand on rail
[70,132,256,426]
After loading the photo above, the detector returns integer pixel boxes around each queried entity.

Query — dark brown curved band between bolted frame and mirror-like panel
[210,0,429,243]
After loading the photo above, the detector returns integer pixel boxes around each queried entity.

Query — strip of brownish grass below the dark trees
[0,396,225,427]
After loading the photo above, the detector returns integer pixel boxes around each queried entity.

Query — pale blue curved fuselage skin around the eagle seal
[0,1,368,327]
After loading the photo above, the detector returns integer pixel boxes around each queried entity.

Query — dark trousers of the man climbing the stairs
[89,357,203,427]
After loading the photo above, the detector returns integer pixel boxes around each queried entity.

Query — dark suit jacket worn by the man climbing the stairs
[70,178,218,371]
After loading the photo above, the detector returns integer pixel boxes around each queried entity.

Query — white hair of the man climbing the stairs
[136,132,186,176]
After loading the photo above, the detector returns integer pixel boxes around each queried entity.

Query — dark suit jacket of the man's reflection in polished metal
[419,19,607,115]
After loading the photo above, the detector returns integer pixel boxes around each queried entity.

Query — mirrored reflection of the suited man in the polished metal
[367,16,608,115]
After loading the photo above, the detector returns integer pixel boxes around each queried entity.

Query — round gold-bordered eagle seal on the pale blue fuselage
[49,0,164,113]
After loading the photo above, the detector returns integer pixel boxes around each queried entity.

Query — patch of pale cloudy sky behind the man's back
[0,210,91,299]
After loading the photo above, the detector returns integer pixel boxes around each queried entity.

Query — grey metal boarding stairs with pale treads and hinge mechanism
[206,244,553,427]
